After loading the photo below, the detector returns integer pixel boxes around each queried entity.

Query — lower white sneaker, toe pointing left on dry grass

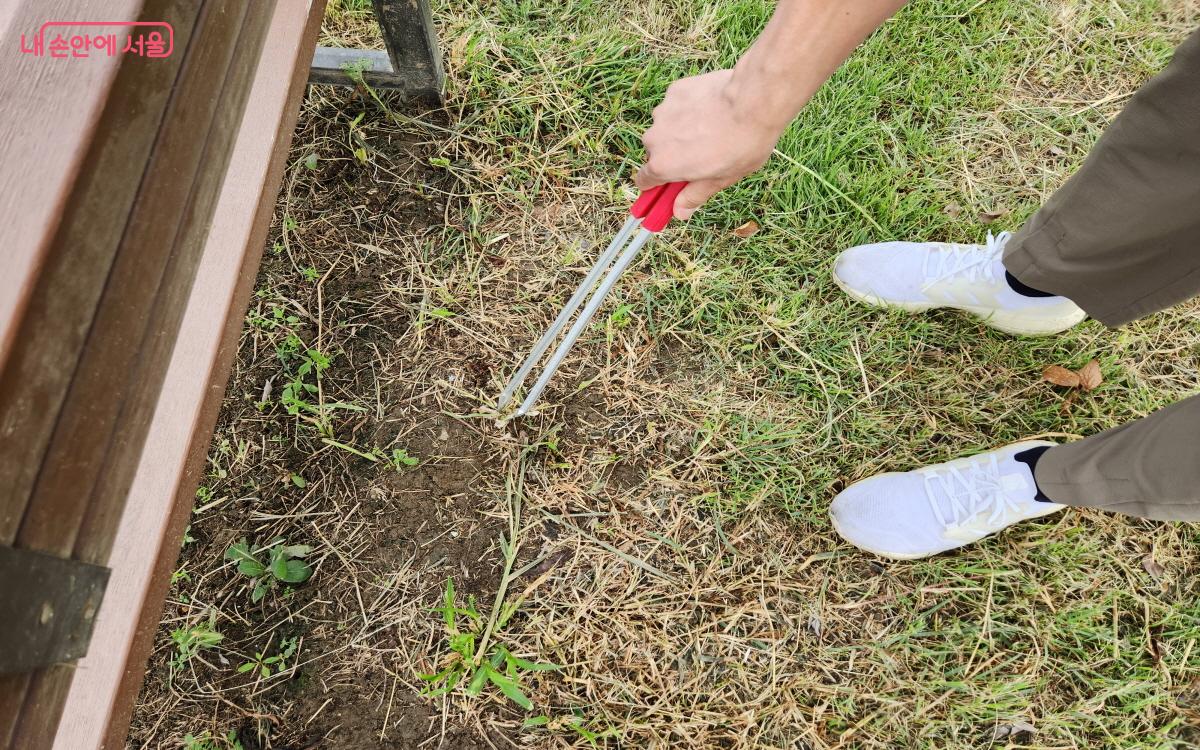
[829,440,1066,560]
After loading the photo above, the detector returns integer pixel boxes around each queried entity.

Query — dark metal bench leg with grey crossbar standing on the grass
[308,0,445,103]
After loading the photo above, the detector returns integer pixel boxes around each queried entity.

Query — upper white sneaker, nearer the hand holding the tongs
[833,232,1087,336]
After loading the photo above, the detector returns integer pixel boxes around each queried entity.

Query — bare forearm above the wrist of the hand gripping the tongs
[727,0,906,130]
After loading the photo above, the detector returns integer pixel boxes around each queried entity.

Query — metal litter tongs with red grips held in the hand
[497,182,688,416]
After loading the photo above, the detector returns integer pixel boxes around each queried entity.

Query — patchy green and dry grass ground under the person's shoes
[130,0,1200,750]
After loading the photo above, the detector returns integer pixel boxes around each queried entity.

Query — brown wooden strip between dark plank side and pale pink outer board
[13,0,274,748]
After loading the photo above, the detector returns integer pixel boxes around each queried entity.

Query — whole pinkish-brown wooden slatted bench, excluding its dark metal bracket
[0,0,324,750]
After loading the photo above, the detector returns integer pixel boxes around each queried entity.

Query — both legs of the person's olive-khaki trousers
[1004,31,1200,521]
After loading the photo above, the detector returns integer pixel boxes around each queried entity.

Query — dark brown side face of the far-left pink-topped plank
[0,0,199,545]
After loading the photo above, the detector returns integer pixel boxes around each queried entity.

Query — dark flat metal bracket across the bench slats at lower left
[0,545,110,674]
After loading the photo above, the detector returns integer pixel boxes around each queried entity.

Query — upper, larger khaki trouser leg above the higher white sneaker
[1004,31,1200,326]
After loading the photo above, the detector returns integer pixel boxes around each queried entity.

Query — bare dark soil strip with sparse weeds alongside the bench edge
[128,90,510,750]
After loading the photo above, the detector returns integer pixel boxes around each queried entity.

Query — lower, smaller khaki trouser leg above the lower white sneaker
[1034,396,1200,521]
